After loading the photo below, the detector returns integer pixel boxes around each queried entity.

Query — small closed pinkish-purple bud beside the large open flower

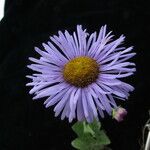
[113,107,127,122]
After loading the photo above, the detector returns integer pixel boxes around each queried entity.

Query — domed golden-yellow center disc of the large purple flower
[63,56,99,88]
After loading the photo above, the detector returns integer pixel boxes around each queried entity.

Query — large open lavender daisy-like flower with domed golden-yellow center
[27,25,135,122]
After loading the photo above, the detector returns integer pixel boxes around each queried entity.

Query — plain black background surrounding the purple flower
[0,0,150,150]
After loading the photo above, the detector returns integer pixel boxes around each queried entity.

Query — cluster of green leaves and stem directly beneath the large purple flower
[71,120,110,150]
